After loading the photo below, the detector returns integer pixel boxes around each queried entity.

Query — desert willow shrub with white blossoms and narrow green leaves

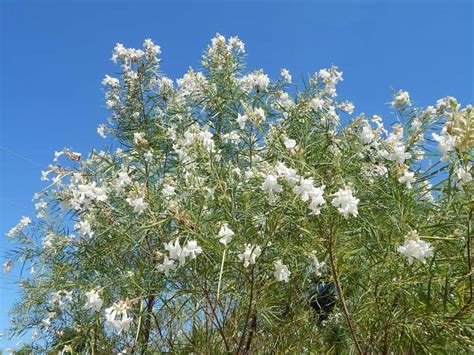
[5,35,474,353]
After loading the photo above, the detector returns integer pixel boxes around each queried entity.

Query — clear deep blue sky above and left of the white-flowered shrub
[0,0,474,349]
